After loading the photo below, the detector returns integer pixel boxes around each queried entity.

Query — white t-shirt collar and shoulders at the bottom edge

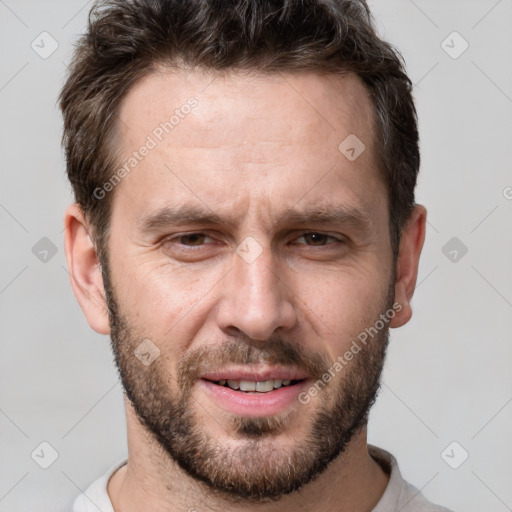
[72,445,453,512]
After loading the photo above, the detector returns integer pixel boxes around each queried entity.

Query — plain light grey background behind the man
[0,0,512,512]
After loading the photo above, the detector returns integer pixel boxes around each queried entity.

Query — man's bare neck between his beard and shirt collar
[107,405,389,512]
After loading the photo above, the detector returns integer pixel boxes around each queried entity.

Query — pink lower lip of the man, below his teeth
[199,379,307,417]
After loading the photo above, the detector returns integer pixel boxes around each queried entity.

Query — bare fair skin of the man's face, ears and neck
[65,69,426,512]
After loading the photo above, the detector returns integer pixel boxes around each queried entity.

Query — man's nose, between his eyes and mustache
[217,243,297,341]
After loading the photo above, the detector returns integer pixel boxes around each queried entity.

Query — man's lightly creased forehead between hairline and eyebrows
[114,69,383,227]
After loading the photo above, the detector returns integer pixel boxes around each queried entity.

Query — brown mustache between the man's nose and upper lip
[177,338,332,390]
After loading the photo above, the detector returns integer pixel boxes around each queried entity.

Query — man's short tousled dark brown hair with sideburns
[59,0,420,260]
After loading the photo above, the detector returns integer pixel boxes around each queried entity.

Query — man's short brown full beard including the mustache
[102,258,394,503]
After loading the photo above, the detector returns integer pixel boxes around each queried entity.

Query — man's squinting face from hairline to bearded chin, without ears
[102,71,394,501]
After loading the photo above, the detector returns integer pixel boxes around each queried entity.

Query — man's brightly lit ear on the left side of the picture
[64,204,110,334]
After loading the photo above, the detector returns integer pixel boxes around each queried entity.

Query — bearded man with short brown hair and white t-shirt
[60,0,456,512]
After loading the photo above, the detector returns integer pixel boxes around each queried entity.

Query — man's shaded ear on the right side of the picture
[390,205,427,327]
